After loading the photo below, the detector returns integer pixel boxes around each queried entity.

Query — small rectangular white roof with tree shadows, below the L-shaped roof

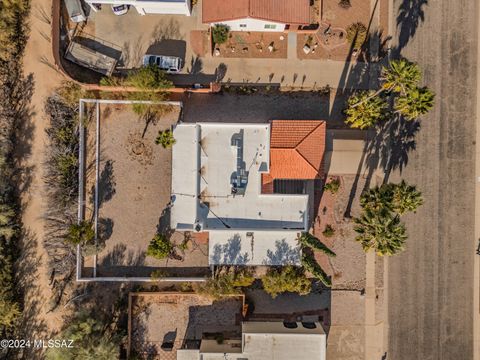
[208,230,301,265]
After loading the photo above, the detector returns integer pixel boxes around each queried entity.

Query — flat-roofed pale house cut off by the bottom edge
[177,321,327,360]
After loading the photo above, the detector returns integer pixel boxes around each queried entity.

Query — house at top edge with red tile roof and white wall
[202,0,310,31]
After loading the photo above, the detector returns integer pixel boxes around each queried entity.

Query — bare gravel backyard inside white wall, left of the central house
[85,105,208,277]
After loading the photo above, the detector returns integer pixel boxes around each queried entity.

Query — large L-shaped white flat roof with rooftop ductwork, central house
[171,123,308,235]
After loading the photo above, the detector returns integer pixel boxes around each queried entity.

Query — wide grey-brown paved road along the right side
[387,0,477,360]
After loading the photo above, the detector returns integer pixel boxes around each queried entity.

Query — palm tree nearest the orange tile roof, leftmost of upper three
[345,91,388,129]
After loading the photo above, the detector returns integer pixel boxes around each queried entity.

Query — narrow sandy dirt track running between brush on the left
[18,0,64,344]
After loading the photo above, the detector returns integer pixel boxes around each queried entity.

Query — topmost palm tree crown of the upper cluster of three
[380,59,422,94]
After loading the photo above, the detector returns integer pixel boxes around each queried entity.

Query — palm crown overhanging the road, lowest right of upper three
[394,87,435,120]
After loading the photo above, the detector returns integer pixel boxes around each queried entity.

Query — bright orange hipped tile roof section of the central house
[269,120,326,179]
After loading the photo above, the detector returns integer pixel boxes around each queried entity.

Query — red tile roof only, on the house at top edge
[202,0,310,25]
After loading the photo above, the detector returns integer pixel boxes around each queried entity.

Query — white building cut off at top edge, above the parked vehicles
[85,0,191,16]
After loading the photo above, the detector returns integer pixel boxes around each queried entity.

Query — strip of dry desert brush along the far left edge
[0,0,33,342]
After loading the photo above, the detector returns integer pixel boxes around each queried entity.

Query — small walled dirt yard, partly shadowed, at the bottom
[129,293,243,359]
